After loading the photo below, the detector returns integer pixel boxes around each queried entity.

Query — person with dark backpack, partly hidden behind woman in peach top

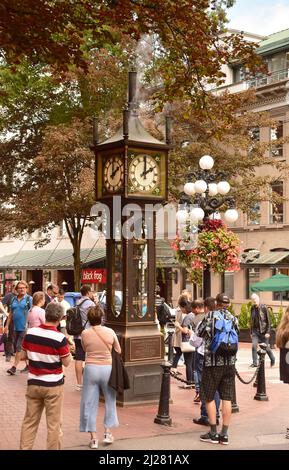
[74,284,95,392]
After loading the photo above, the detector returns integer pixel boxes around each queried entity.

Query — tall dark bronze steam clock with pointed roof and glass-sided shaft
[94,72,170,406]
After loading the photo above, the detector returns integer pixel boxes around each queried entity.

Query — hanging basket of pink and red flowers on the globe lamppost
[172,219,240,285]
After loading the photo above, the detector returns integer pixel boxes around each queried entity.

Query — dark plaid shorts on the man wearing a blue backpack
[200,366,235,401]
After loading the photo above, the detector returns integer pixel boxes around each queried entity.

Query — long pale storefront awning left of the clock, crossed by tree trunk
[0,248,105,270]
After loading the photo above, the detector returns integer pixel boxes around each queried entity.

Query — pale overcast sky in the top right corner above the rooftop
[227,0,289,36]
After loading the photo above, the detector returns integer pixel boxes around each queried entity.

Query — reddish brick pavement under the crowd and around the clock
[0,343,289,450]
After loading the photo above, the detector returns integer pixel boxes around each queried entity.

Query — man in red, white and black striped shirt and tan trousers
[20,302,71,450]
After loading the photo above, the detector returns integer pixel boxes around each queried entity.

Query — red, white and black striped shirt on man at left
[22,325,70,387]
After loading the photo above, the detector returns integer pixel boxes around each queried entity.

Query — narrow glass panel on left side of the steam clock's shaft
[112,241,123,317]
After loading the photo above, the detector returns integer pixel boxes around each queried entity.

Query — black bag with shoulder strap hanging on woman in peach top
[93,328,130,393]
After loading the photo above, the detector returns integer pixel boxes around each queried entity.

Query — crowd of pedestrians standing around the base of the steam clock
[0,281,289,450]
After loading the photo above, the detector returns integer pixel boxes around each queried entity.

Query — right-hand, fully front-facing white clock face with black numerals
[129,154,160,192]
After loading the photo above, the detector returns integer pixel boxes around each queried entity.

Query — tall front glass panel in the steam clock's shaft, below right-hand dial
[132,239,148,318]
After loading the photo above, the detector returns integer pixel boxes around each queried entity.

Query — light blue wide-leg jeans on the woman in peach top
[79,364,118,432]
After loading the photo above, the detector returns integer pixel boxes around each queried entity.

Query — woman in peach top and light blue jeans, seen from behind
[80,305,121,449]
